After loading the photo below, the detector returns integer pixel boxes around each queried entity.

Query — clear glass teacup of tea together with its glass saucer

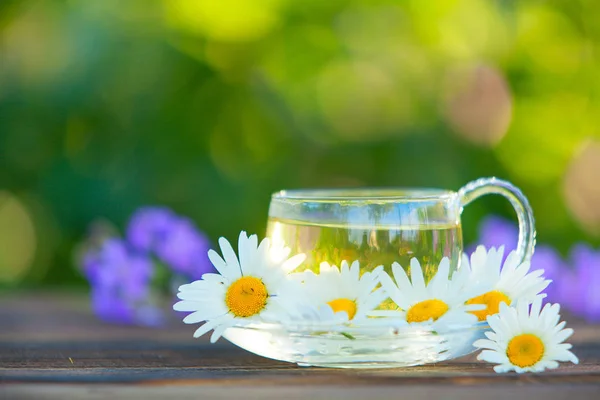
[224,178,535,368]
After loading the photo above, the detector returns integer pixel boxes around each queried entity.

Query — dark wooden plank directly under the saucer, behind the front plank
[0,341,600,377]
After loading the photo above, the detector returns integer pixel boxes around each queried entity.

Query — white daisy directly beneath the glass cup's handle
[460,246,552,321]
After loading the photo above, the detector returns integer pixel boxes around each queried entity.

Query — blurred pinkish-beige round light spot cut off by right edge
[563,141,600,235]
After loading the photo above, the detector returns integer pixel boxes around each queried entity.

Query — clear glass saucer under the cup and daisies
[223,321,489,368]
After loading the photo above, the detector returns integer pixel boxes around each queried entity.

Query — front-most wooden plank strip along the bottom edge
[0,384,599,400]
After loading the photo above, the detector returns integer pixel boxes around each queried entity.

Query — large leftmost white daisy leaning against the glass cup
[173,232,305,343]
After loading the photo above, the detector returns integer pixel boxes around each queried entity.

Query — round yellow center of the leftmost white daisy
[225,276,269,318]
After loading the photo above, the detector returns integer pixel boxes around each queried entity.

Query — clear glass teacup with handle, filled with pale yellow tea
[267,178,535,281]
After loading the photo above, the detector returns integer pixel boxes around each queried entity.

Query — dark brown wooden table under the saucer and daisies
[0,292,600,400]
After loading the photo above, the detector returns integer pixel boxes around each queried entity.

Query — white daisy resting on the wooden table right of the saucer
[473,296,579,373]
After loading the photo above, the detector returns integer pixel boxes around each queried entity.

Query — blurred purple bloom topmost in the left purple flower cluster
[127,207,177,252]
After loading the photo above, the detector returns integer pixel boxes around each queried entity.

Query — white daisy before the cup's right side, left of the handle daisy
[370,257,482,331]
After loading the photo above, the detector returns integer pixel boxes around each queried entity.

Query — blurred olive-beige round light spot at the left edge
[0,191,36,283]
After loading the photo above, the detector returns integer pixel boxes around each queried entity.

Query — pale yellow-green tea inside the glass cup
[267,218,462,282]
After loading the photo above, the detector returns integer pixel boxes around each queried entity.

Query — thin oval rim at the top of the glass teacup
[271,187,457,202]
